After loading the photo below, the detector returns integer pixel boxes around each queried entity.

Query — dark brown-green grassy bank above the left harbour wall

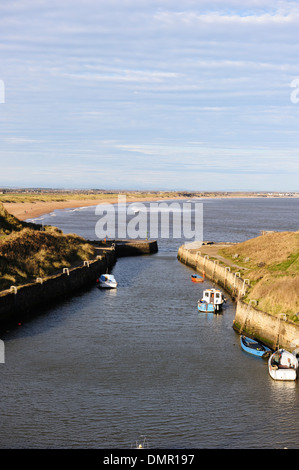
[0,204,95,290]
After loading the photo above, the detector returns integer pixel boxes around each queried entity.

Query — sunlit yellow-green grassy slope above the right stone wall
[219,231,299,319]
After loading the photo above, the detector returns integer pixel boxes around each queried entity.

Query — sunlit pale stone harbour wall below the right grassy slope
[177,244,299,351]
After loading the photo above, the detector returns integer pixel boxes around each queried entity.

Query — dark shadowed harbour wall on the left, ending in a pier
[0,240,158,327]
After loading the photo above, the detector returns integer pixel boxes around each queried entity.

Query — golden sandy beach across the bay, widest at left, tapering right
[3,196,189,220]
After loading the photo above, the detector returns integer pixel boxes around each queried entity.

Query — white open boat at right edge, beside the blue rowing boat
[268,349,298,380]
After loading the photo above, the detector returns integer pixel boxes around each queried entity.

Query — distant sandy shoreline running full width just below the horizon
[0,193,299,221]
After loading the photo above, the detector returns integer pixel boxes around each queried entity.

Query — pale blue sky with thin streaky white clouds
[0,0,299,192]
